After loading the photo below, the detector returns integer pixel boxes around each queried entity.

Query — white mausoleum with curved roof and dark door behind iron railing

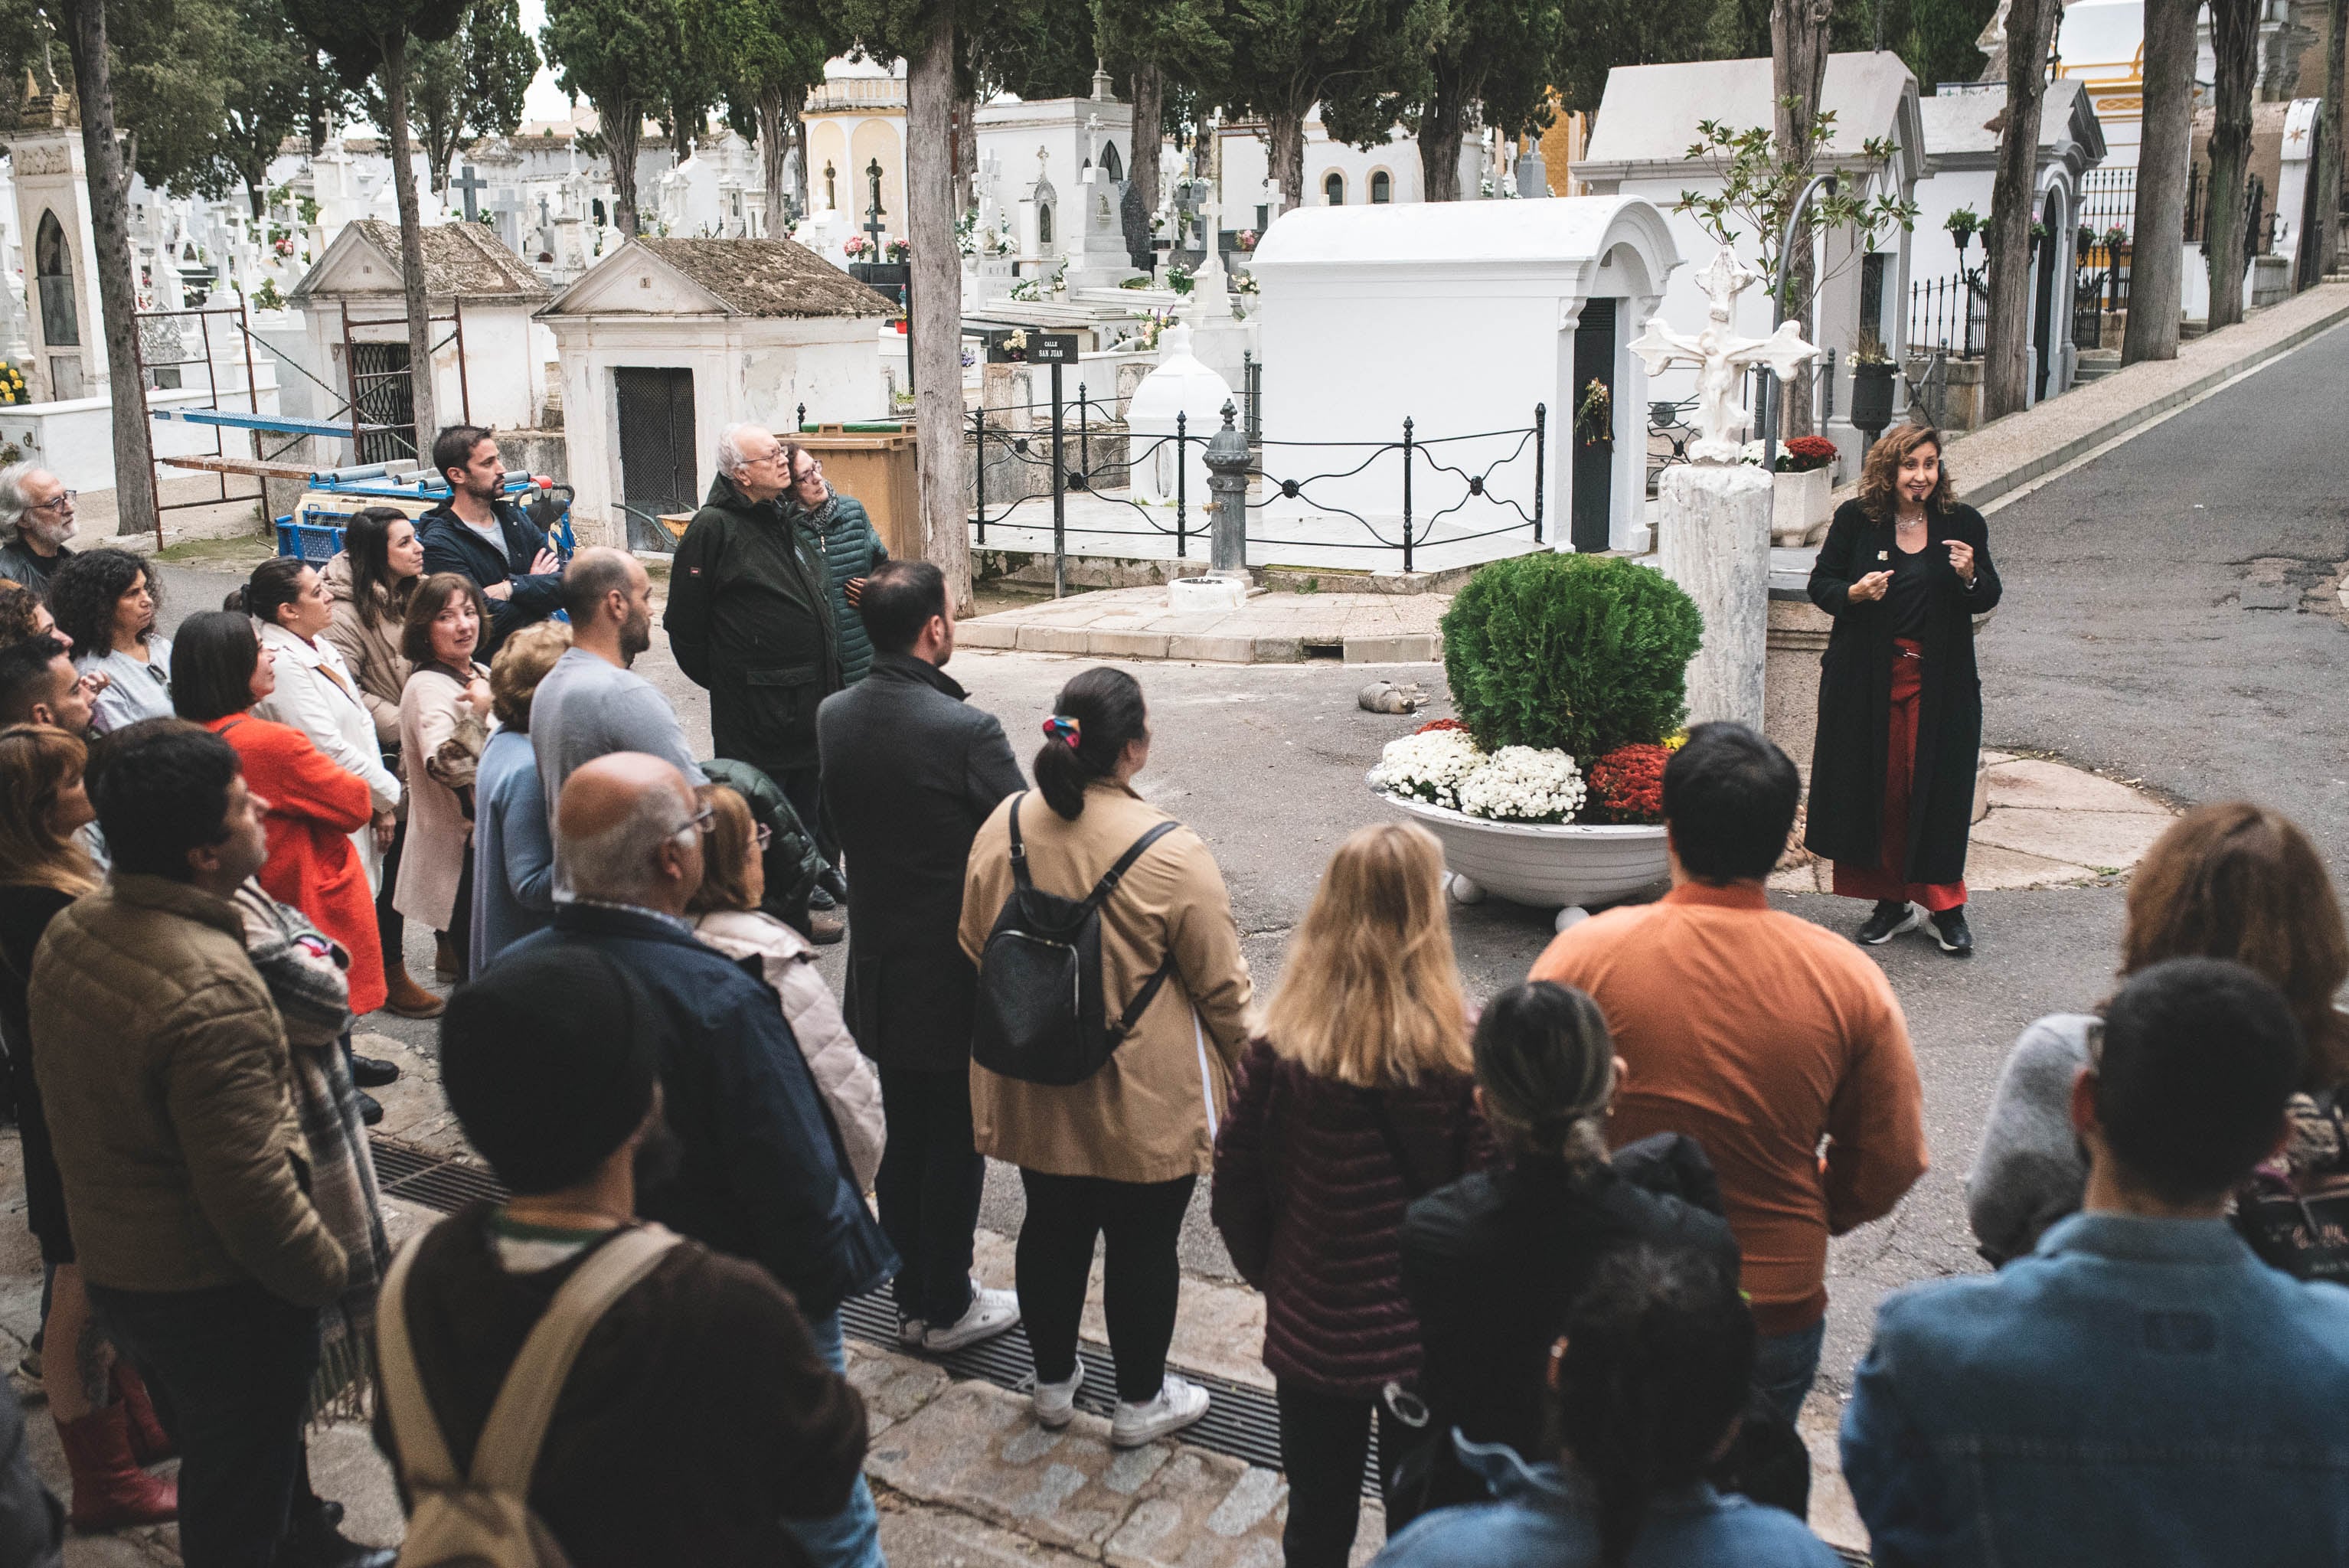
[1250,198,1684,554]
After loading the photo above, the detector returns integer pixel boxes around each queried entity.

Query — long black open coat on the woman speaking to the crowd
[1802,500,1999,883]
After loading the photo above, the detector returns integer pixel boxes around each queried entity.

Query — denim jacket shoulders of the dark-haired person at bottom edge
[1372,1439,1844,1568]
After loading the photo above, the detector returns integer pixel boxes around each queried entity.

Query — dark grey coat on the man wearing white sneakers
[815,652,1027,1073]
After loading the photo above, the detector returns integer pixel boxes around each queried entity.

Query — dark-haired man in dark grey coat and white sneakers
[815,561,1024,1352]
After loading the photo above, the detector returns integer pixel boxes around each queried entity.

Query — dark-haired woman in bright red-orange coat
[172,610,385,1014]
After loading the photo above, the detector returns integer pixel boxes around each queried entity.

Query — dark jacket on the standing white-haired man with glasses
[660,474,841,777]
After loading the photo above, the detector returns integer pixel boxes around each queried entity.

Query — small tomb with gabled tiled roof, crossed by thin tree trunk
[286,218,552,443]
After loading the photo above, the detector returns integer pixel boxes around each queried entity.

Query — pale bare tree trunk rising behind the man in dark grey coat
[904,7,970,612]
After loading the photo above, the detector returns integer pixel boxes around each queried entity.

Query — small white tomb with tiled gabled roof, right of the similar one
[538,240,895,549]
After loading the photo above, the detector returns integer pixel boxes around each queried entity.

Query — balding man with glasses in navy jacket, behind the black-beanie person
[509,751,897,1568]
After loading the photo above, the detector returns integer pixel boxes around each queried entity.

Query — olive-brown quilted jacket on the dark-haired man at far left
[28,874,345,1308]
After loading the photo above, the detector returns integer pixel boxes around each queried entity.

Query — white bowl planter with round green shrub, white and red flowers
[1370,551,1703,927]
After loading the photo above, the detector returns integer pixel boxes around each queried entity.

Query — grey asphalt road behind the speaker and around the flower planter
[146,331,2349,1387]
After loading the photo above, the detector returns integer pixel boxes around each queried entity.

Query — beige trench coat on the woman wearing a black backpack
[961,782,1254,1183]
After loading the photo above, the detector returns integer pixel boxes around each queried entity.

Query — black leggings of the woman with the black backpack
[1020,1171,1198,1403]
